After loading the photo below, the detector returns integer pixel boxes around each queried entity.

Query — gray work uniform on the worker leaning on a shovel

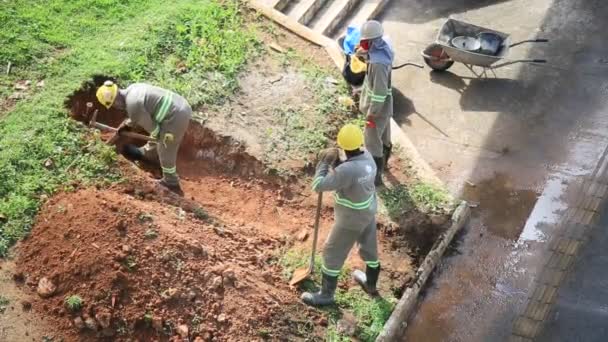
[312,151,379,276]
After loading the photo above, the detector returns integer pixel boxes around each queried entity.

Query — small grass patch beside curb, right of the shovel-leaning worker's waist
[379,182,453,219]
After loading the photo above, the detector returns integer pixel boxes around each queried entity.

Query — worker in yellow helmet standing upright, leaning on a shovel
[302,124,380,306]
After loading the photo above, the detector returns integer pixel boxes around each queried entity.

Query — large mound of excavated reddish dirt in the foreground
[17,188,306,341]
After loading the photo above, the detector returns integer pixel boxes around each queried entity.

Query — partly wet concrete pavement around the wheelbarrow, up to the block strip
[382,0,608,342]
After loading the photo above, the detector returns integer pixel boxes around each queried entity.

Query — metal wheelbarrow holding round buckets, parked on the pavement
[422,19,549,76]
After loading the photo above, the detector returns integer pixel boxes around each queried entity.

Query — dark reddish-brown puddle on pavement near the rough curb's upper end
[463,173,538,240]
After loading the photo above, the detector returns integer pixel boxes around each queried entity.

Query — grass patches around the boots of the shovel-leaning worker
[278,249,397,341]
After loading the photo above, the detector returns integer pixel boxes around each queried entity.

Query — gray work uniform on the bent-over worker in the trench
[124,83,192,185]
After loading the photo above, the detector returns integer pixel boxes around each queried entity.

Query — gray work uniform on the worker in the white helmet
[359,63,393,158]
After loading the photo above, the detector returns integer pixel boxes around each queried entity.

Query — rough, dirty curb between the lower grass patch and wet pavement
[376,201,471,342]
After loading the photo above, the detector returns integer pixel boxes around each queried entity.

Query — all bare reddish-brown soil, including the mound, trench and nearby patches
[3,23,448,341]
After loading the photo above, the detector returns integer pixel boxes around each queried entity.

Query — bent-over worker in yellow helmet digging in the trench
[97,81,192,195]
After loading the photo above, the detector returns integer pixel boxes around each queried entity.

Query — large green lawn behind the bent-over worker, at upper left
[0,0,257,256]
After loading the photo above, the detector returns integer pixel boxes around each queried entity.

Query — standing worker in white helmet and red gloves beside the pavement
[357,20,394,186]
